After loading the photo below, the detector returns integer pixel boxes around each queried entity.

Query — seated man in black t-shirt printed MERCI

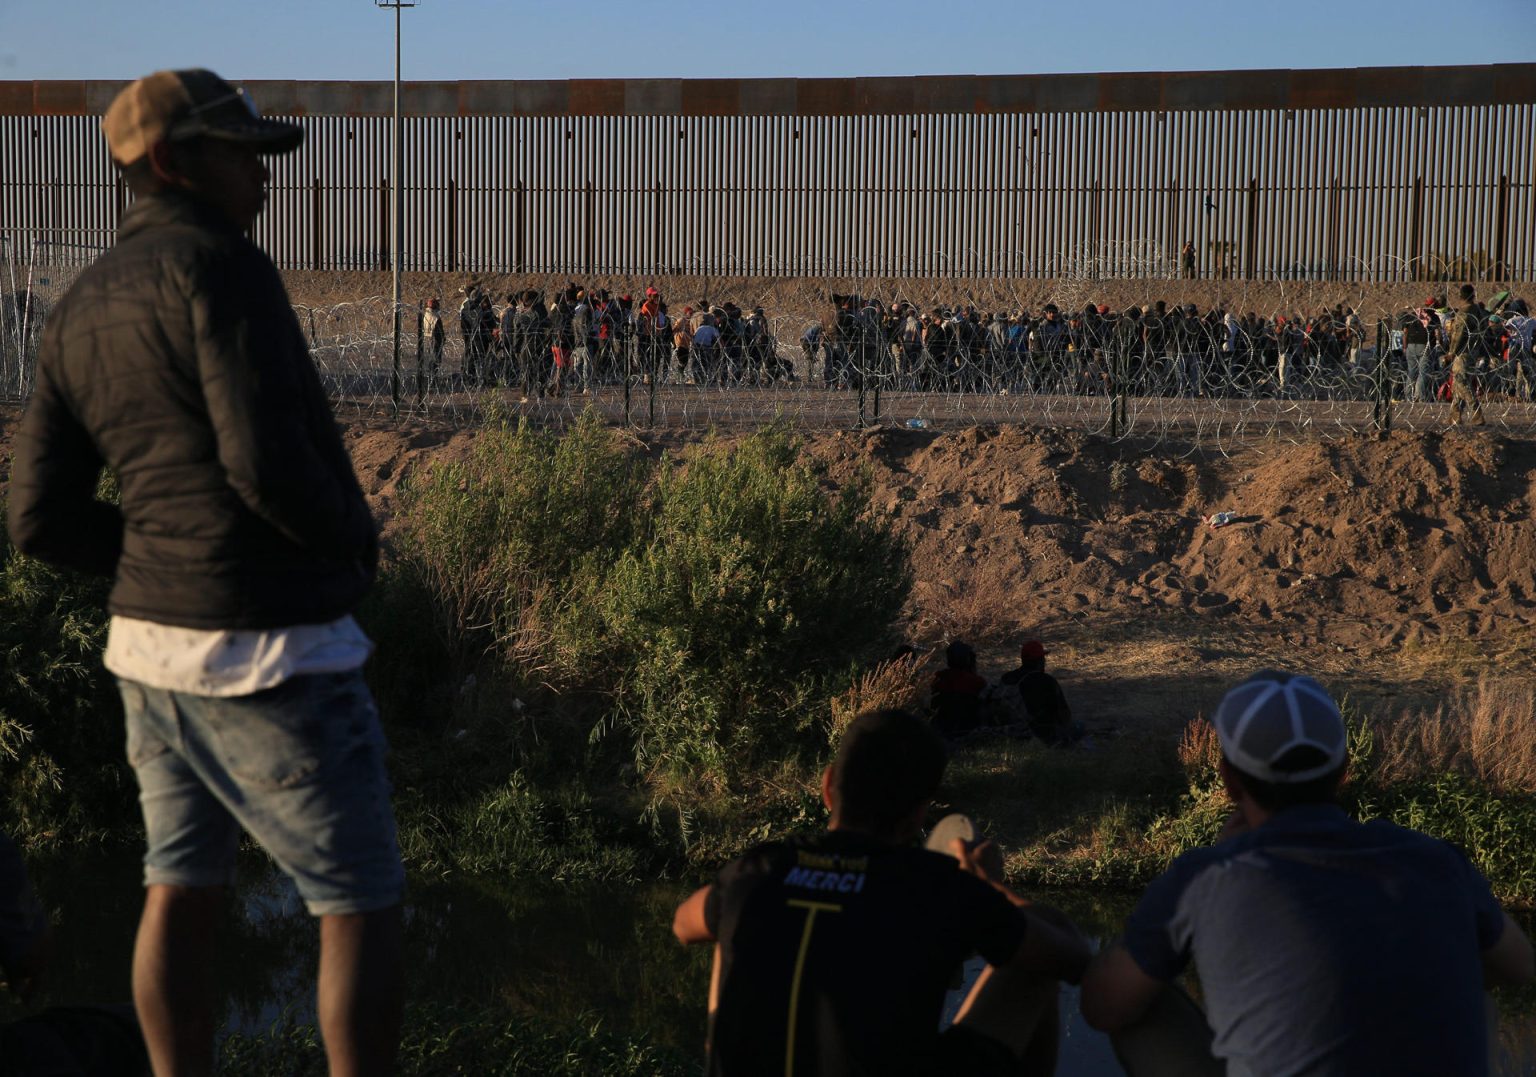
[673,710,1087,1077]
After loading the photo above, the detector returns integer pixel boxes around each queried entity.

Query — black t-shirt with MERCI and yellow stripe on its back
[705,831,1025,1077]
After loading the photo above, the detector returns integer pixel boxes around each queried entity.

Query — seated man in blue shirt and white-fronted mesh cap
[1083,670,1533,1077]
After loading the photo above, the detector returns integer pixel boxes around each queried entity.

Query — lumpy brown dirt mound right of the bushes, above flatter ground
[814,427,1536,650]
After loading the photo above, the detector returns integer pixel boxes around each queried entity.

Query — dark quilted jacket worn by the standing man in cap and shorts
[9,195,378,628]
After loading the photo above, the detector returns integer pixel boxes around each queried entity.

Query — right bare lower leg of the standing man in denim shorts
[319,905,404,1077]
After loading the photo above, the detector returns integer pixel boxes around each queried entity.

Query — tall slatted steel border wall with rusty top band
[0,65,1536,281]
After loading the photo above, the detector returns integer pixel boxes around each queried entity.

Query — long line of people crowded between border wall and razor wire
[422,284,1536,403]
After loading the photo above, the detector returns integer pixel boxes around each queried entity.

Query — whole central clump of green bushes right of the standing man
[380,415,911,876]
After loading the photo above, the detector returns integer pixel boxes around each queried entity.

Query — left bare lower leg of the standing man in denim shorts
[134,883,224,1077]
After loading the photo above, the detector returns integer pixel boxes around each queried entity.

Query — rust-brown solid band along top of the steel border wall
[0,63,1536,117]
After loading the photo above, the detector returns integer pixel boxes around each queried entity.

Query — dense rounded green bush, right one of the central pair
[556,426,911,790]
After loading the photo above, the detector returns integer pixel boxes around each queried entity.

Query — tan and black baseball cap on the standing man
[101,68,304,164]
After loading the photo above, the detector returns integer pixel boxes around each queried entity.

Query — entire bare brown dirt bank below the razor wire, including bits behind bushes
[0,412,1536,724]
